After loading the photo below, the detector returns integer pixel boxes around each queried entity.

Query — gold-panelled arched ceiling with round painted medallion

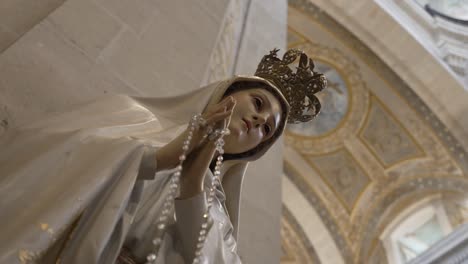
[281,0,468,263]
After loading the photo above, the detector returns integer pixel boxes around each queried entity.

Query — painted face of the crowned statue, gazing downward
[224,88,281,154]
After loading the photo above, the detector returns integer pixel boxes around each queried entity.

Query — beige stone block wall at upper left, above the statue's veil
[0,0,227,127]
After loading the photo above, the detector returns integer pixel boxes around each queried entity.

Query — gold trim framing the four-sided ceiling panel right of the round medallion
[357,95,428,169]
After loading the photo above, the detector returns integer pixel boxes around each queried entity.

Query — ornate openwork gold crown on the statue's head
[255,49,327,123]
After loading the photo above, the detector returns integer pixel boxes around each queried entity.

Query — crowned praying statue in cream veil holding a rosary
[0,50,326,264]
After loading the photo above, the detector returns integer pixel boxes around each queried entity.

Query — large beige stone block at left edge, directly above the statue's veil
[0,21,132,126]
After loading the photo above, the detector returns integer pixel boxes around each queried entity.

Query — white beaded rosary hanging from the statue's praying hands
[146,114,229,264]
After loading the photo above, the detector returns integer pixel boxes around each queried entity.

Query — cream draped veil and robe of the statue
[0,77,288,264]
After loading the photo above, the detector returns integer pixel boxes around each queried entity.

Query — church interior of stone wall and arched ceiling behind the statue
[0,0,468,264]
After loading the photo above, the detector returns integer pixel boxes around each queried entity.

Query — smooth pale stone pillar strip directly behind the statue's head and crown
[234,0,287,264]
